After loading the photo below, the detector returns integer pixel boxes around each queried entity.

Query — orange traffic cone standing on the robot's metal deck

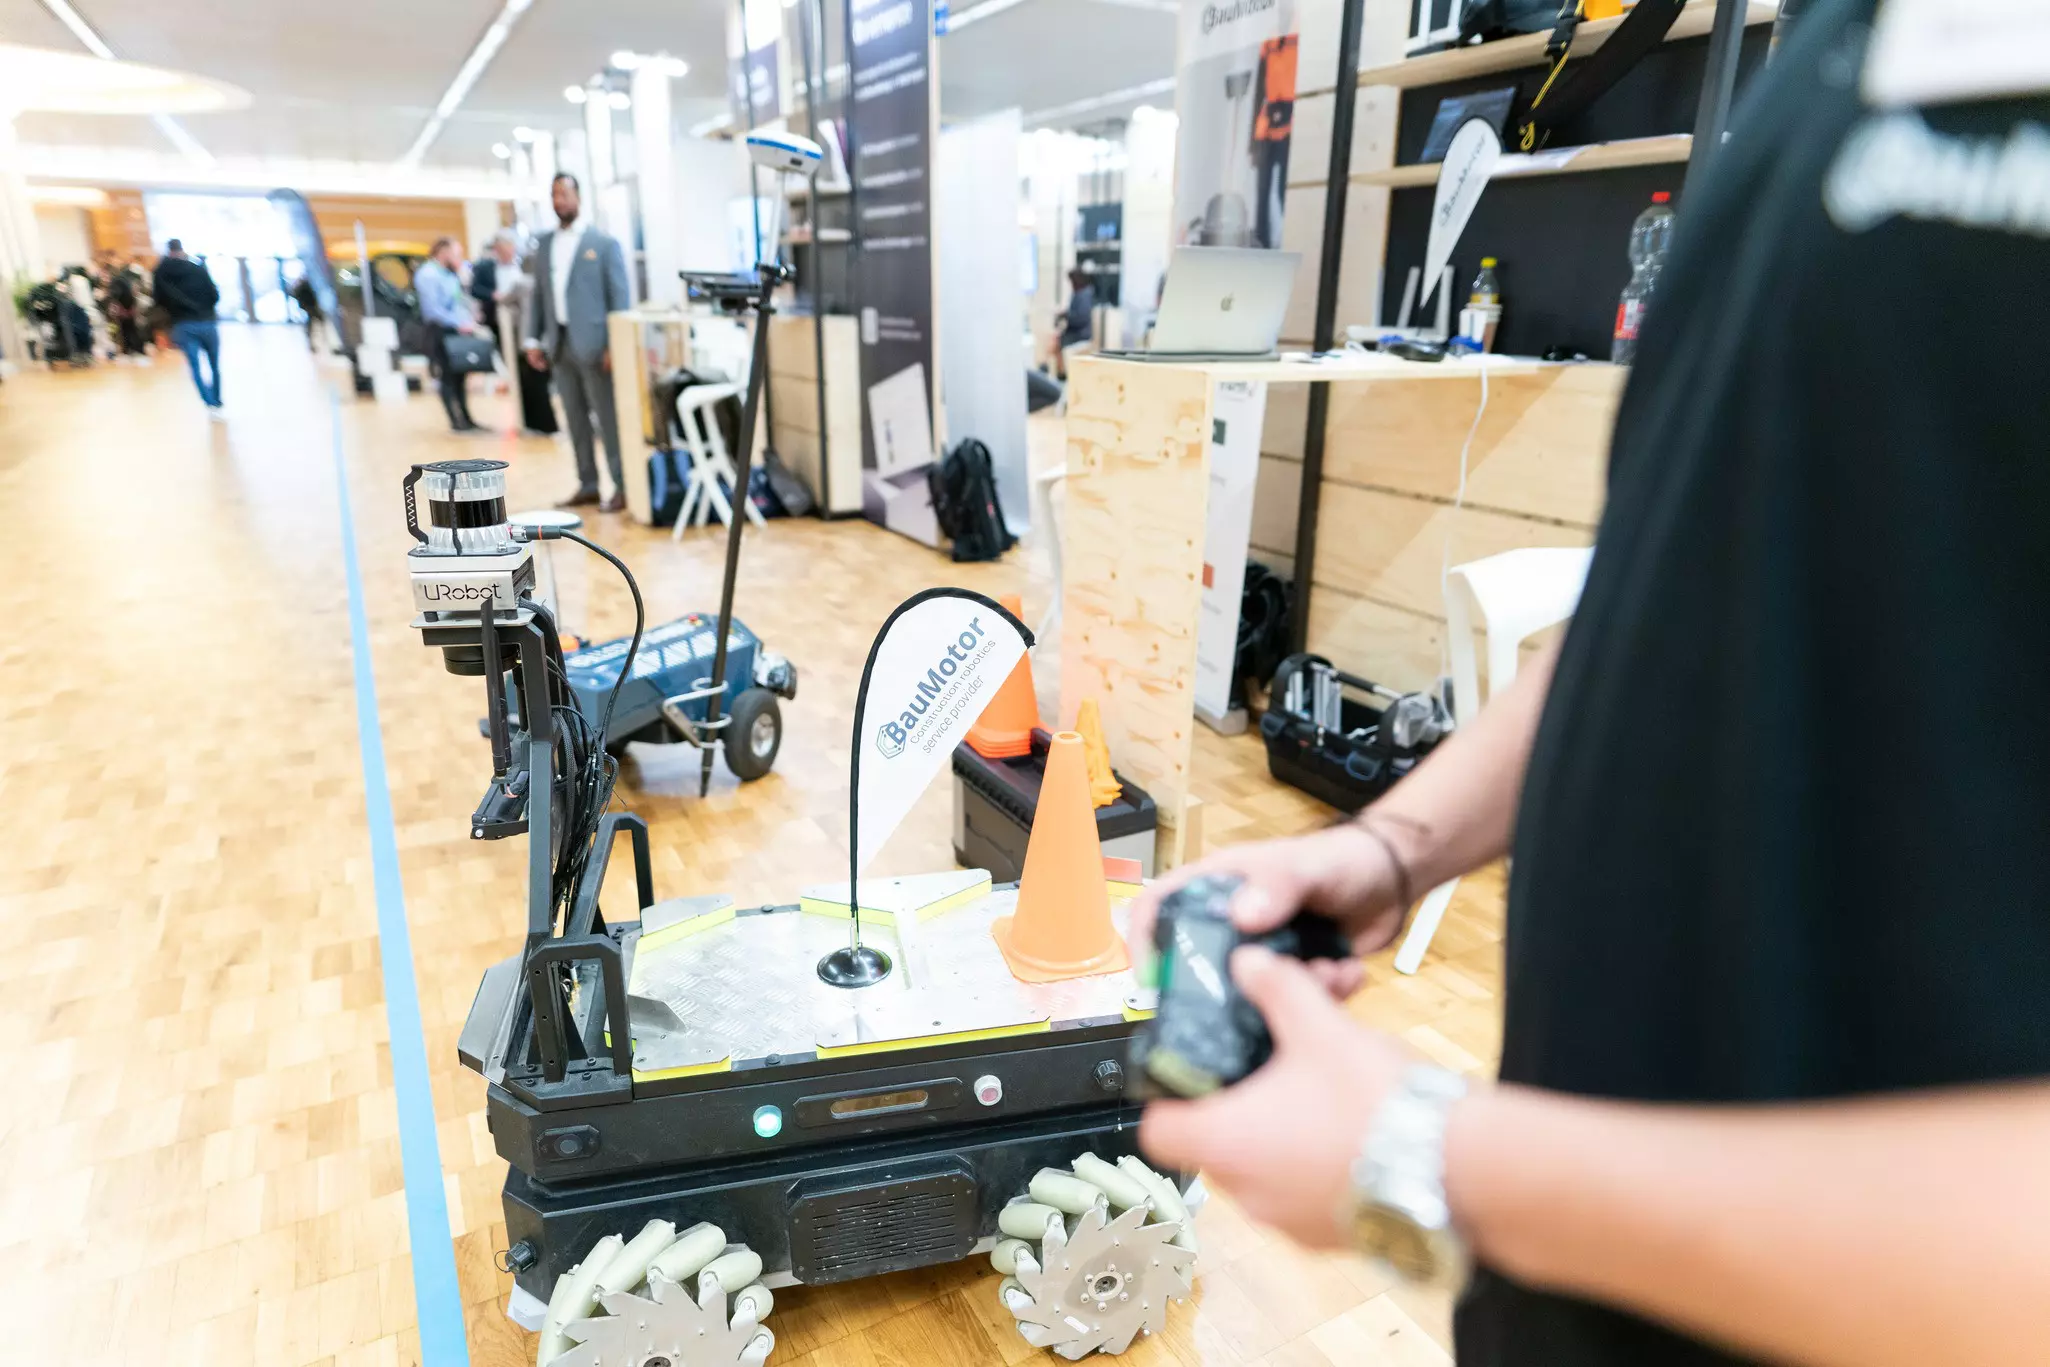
[990,732,1130,982]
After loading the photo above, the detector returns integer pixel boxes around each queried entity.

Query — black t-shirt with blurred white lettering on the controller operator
[1458,0,2050,1367]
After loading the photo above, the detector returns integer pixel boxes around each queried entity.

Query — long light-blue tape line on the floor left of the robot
[332,389,469,1367]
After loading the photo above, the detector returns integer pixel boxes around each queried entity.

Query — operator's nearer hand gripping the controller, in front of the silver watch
[1140,945,1410,1248]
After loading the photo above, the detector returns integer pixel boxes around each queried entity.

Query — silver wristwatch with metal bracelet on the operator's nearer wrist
[1343,1064,1468,1287]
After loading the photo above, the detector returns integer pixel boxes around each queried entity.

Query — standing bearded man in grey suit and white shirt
[521,172,629,512]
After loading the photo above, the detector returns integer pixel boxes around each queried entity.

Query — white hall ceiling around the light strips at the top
[0,0,1175,170]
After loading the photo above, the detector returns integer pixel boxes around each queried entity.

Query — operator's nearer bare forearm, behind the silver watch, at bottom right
[1447,1084,2050,1367]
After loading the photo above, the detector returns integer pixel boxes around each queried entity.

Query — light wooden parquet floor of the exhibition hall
[0,328,1501,1367]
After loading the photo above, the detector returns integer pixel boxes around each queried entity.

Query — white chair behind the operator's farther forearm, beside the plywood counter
[1396,547,1595,974]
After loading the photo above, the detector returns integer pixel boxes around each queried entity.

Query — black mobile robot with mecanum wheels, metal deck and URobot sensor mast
[408,216,1195,1367]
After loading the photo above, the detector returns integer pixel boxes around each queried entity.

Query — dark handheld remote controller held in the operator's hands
[1132,875,1353,1096]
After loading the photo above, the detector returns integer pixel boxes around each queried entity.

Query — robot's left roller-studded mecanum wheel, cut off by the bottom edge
[537,1219,775,1367]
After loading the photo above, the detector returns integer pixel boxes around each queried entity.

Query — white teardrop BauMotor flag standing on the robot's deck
[853,588,1031,877]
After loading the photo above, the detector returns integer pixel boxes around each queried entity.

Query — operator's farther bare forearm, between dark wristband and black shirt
[1359,644,1558,896]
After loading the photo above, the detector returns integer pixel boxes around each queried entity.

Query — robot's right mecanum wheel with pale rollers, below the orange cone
[990,1154,1195,1361]
